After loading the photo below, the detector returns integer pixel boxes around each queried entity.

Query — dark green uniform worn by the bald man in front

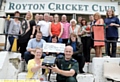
[56,57,79,80]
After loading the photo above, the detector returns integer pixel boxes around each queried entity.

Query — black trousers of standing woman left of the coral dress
[81,37,91,62]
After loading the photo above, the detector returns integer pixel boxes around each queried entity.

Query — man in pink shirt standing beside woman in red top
[61,15,70,44]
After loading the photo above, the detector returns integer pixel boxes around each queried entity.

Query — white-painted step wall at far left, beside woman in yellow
[0,51,21,79]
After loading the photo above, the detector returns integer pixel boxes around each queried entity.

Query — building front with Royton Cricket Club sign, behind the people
[0,0,120,38]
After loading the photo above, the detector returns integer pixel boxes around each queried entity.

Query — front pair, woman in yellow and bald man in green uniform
[27,46,79,82]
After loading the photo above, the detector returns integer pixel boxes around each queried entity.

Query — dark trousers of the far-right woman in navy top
[106,37,118,57]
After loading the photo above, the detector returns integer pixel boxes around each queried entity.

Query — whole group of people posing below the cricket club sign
[8,9,120,82]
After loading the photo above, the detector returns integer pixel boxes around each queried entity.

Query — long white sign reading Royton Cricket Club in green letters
[5,0,118,15]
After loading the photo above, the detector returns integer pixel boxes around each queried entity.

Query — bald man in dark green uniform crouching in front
[50,46,79,82]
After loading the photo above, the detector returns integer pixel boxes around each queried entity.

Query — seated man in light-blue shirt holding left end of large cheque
[24,32,46,63]
